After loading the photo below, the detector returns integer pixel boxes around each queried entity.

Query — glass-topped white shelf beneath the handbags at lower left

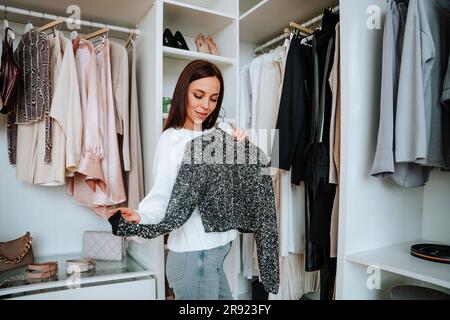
[0,254,155,297]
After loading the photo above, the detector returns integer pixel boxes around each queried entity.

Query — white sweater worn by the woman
[137,128,237,252]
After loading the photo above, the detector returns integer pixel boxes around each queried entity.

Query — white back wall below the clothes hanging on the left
[0,22,111,256]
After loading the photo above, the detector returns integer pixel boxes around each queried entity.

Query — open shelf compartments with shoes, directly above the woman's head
[161,0,239,122]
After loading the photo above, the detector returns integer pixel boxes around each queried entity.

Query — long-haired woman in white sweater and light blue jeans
[111,60,245,300]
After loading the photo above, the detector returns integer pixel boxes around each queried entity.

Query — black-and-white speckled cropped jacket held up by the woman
[109,129,279,294]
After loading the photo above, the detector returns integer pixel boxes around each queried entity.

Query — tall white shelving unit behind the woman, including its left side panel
[135,0,243,299]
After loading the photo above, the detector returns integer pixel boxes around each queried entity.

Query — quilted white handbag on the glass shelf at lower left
[81,231,126,261]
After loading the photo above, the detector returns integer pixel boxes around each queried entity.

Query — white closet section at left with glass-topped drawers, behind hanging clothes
[0,11,164,300]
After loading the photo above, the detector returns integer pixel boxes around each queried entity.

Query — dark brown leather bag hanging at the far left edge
[0,28,22,114]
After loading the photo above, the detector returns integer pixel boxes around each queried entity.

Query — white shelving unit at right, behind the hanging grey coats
[336,0,450,299]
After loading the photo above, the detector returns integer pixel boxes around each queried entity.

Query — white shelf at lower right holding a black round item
[347,240,450,288]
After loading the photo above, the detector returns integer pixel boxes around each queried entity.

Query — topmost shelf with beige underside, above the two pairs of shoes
[164,0,236,38]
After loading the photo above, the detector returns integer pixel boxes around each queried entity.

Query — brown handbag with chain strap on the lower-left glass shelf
[0,232,34,272]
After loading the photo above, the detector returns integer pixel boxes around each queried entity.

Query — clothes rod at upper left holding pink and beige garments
[0,5,139,35]
